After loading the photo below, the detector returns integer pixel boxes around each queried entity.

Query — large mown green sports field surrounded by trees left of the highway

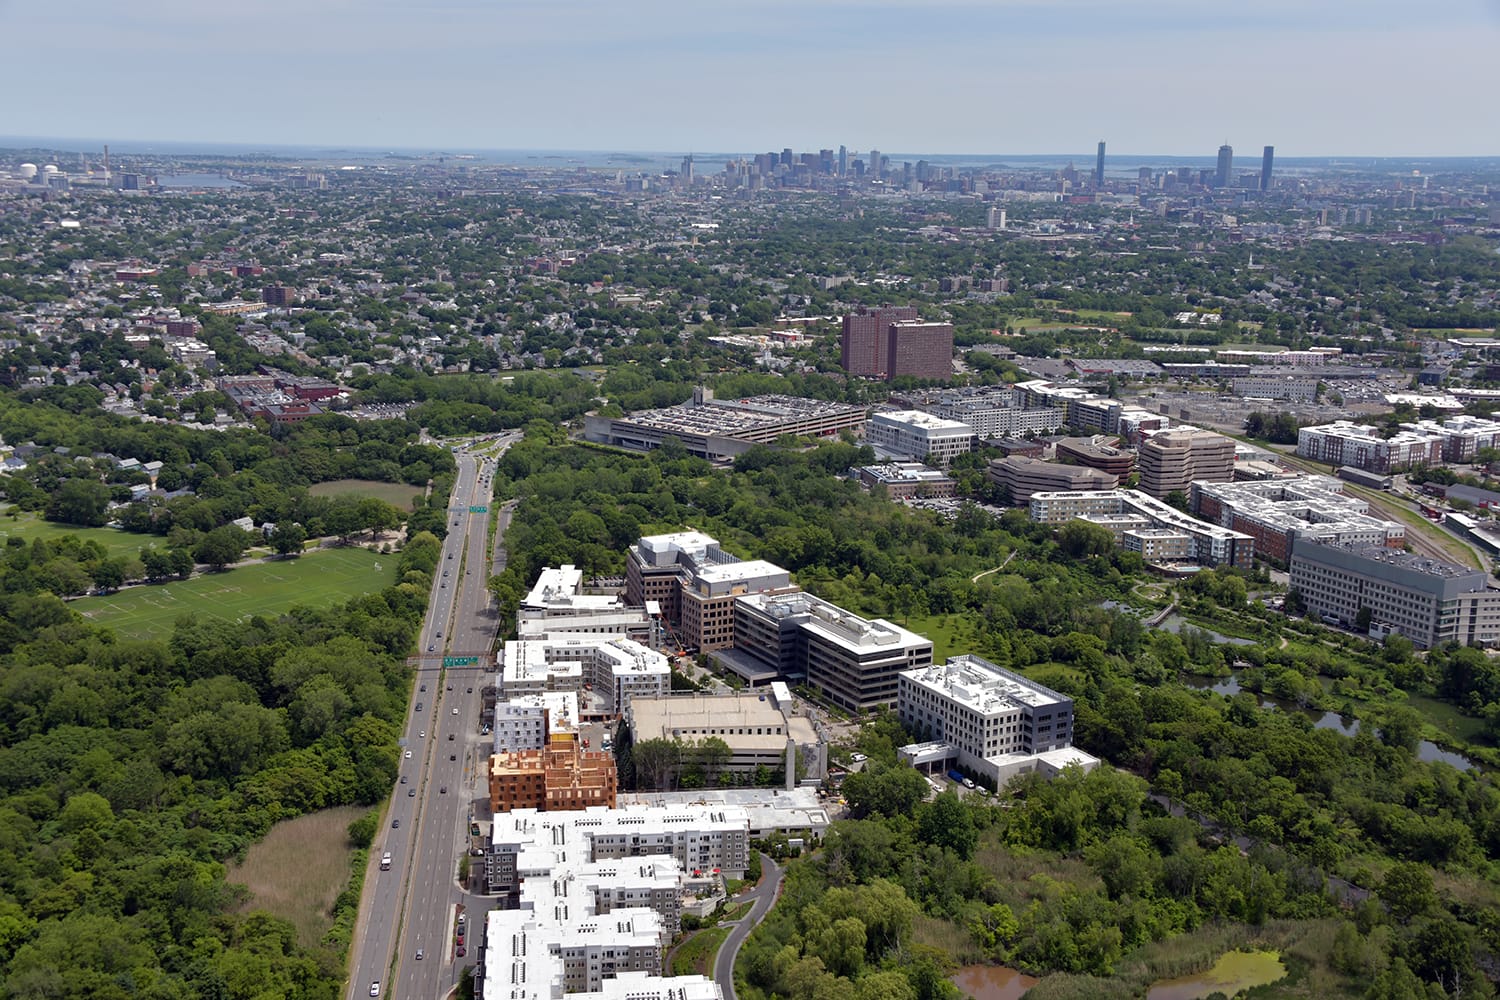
[72,549,396,639]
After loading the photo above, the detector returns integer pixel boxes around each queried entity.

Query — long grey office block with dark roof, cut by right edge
[1290,543,1500,649]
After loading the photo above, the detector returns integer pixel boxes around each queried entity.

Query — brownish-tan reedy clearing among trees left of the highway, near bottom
[227,805,366,948]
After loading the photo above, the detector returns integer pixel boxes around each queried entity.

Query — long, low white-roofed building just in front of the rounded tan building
[1028,490,1256,570]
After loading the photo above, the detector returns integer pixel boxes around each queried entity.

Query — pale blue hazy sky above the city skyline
[0,0,1500,157]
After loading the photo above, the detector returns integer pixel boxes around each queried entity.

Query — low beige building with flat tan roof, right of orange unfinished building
[626,681,828,783]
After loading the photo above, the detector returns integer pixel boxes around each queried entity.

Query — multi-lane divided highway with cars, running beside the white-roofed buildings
[347,432,521,1000]
